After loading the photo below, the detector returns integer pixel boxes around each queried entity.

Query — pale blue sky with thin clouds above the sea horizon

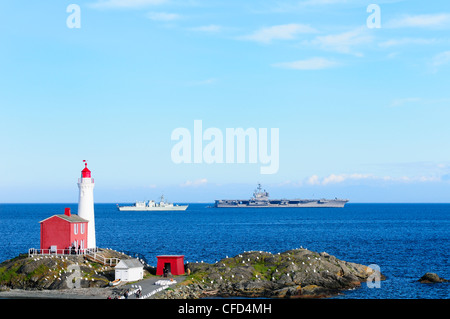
[0,0,450,203]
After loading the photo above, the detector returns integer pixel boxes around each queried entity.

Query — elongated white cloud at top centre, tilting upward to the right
[239,23,317,43]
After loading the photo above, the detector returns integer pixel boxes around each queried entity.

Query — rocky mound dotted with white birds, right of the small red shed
[158,249,385,299]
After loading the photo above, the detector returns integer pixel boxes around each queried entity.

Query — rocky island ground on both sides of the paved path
[0,248,385,299]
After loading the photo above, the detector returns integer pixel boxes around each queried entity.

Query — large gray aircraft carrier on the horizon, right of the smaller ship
[214,184,348,208]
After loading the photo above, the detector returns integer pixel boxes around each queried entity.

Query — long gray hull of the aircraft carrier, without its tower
[215,199,348,208]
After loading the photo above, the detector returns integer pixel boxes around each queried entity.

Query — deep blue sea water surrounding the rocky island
[0,203,450,299]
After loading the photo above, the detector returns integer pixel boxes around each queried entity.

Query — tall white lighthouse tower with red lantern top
[78,160,96,248]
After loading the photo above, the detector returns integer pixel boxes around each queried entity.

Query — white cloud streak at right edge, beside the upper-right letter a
[386,13,450,28]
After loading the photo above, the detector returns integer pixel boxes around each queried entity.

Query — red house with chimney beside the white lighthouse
[39,208,88,254]
